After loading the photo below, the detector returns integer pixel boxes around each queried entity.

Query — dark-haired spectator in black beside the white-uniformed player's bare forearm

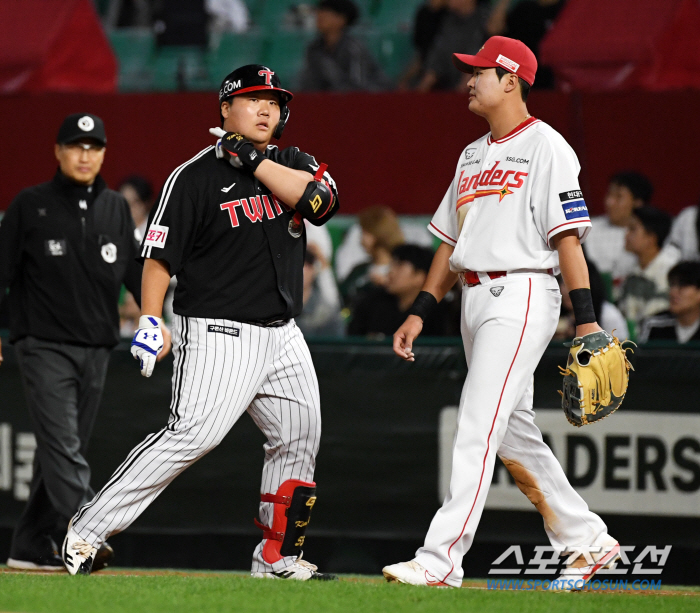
[348,245,447,337]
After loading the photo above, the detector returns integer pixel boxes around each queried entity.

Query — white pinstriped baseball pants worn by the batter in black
[73,315,321,572]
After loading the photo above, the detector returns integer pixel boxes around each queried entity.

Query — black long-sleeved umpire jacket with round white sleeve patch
[0,170,142,347]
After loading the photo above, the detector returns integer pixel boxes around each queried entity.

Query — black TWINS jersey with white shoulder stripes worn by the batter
[141,146,338,323]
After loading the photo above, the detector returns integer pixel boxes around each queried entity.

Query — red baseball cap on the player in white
[452,36,537,85]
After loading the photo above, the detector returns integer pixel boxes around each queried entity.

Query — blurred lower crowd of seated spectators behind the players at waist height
[108,171,700,343]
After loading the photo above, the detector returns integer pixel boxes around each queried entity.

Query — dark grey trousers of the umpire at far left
[10,337,110,559]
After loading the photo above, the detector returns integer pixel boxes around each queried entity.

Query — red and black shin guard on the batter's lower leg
[253,479,316,564]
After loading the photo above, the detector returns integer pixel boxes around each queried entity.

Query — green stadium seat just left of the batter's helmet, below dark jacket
[153,46,209,91]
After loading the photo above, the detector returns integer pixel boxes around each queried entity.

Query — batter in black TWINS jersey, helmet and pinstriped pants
[62,65,338,581]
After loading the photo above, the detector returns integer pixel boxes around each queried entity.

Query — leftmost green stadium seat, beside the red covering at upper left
[109,28,155,91]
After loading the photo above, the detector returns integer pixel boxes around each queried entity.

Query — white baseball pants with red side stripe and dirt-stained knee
[416,272,607,586]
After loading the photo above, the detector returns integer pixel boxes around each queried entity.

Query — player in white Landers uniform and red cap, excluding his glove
[383,36,619,590]
